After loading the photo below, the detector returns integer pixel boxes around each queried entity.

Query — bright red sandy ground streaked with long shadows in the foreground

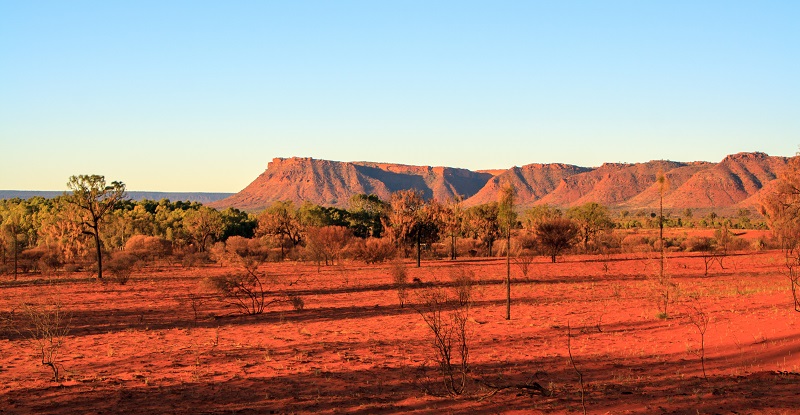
[0,244,800,415]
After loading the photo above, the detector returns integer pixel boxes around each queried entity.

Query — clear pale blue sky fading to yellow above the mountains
[0,0,800,192]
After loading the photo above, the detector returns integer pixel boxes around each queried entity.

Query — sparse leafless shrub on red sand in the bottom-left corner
[18,300,71,382]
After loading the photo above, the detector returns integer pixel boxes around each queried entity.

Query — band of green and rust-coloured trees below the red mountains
[0,187,763,275]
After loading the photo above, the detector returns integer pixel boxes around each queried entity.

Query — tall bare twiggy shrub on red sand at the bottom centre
[414,287,470,396]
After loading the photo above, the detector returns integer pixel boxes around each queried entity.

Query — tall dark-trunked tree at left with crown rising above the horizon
[66,174,126,279]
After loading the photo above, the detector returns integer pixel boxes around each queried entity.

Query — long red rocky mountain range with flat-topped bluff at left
[211,153,787,211]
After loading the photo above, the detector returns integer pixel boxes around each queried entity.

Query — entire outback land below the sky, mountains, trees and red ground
[0,153,800,414]
